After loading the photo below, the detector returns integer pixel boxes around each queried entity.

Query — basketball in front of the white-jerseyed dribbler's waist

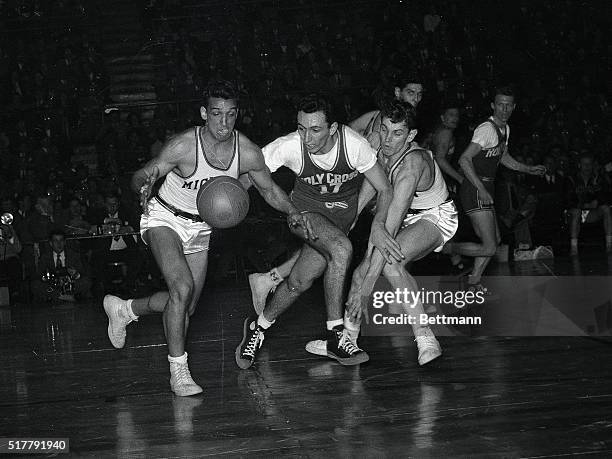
[196,176,249,229]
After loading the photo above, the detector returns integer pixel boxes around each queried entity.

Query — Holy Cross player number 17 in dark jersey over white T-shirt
[236,94,403,369]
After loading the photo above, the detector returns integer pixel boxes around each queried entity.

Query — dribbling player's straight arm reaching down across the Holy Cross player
[240,136,317,239]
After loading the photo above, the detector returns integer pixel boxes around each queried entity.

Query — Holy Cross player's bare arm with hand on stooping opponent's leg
[364,161,404,262]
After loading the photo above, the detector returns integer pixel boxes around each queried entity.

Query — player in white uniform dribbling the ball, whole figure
[104,81,316,396]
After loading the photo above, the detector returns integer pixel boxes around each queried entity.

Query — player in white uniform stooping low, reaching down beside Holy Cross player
[306,101,458,365]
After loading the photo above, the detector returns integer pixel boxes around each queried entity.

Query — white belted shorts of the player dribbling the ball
[140,198,212,255]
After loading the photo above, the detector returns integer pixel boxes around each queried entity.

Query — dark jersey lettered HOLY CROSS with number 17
[293,125,363,202]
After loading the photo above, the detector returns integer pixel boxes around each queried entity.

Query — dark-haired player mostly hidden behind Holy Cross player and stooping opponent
[249,73,423,314]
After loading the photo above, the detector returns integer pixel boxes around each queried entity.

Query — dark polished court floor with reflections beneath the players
[0,254,612,458]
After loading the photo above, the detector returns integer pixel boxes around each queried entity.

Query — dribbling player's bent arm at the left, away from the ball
[131,130,190,210]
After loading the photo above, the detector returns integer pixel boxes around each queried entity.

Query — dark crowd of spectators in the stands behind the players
[0,0,612,306]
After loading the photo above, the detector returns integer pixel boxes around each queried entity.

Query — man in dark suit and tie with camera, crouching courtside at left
[32,230,91,301]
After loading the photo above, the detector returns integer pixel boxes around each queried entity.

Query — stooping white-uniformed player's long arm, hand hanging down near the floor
[346,154,423,322]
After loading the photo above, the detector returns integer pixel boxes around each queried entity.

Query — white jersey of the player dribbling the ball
[159,126,240,214]
